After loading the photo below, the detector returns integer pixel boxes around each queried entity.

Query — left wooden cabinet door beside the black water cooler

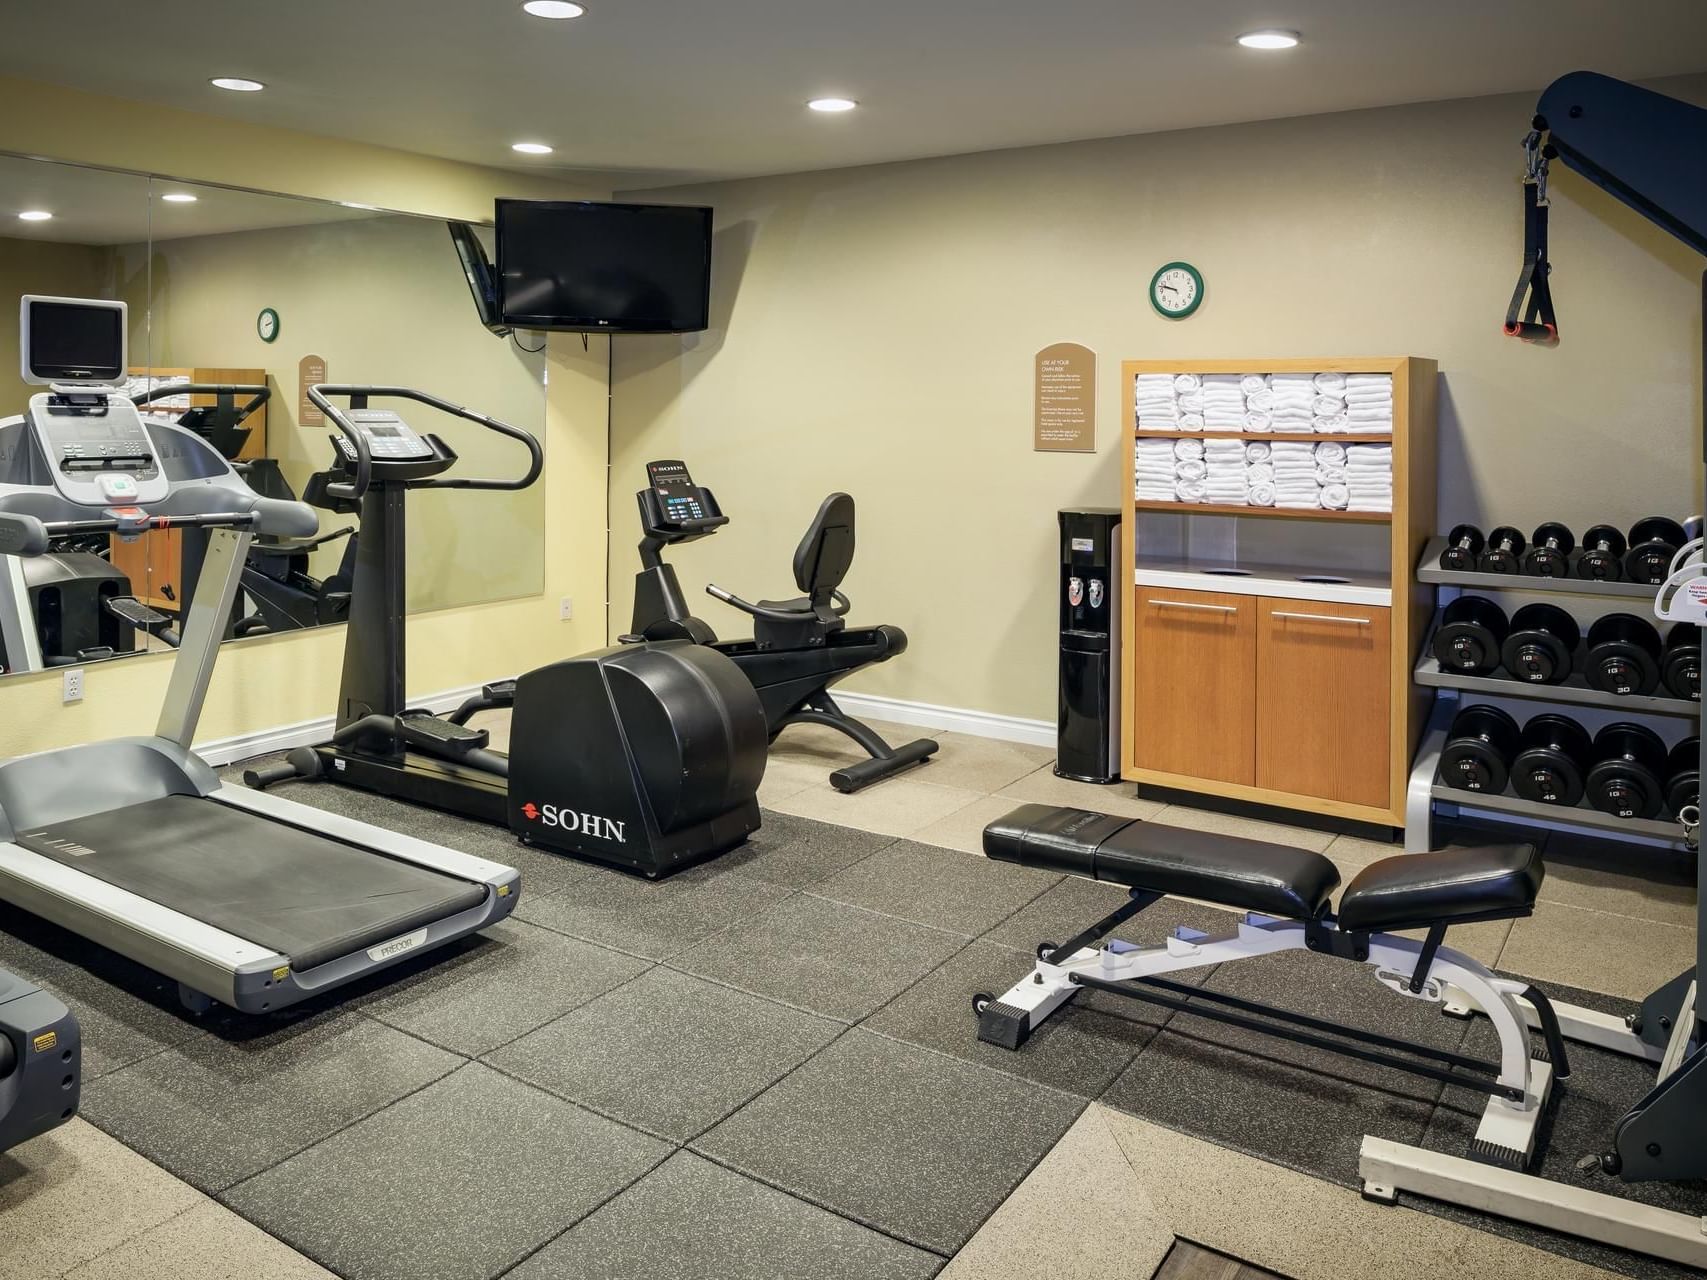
[1132,587,1258,785]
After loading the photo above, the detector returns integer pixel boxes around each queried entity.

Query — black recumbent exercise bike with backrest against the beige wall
[635,461,937,792]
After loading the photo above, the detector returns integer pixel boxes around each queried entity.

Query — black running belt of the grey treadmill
[15,795,486,973]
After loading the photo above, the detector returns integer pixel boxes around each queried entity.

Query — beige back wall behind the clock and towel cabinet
[611,79,1707,719]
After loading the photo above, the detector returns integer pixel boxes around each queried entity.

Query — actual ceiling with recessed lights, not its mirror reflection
[0,0,1707,186]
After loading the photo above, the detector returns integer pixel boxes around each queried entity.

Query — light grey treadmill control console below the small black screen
[27,389,167,510]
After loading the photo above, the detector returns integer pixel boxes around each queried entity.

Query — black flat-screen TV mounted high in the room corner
[497,200,712,333]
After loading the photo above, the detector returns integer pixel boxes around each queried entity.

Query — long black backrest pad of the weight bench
[983,804,1340,920]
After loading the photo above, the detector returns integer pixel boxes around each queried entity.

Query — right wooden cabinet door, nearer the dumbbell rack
[1256,599,1391,809]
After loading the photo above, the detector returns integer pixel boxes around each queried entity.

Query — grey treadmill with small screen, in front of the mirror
[0,297,521,1014]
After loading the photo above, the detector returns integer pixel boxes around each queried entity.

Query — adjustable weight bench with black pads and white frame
[973,804,1569,1198]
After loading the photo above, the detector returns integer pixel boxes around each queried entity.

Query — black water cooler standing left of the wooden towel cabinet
[1055,507,1123,782]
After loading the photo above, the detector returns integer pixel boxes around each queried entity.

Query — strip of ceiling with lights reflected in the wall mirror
[0,155,389,246]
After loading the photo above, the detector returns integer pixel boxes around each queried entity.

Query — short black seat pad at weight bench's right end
[1340,845,1545,932]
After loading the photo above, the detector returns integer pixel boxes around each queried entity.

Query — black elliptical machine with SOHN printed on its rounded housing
[244,386,765,877]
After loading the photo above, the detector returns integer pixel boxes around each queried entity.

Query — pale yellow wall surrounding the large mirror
[0,79,608,756]
